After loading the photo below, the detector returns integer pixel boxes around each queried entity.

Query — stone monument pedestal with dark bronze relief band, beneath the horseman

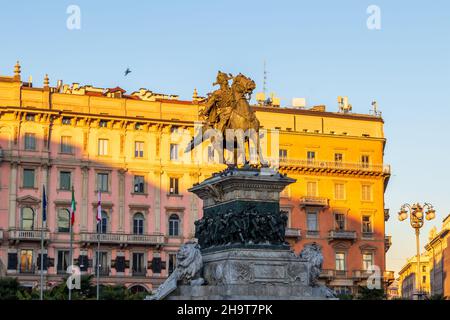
[165,168,332,300]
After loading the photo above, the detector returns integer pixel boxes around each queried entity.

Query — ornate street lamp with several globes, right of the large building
[398,202,436,300]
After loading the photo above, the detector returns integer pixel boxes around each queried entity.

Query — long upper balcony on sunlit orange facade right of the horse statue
[270,158,391,175]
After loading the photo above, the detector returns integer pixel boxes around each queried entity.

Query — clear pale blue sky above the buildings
[0,0,450,276]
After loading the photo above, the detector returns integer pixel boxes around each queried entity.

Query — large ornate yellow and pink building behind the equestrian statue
[0,64,393,293]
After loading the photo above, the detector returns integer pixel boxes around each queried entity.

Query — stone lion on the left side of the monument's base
[147,242,204,300]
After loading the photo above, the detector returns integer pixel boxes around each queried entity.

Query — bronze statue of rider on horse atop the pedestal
[186,71,260,164]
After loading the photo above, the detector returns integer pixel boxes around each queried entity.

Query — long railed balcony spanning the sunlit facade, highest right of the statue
[270,158,391,174]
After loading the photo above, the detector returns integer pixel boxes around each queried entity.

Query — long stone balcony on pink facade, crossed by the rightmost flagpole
[80,232,164,245]
